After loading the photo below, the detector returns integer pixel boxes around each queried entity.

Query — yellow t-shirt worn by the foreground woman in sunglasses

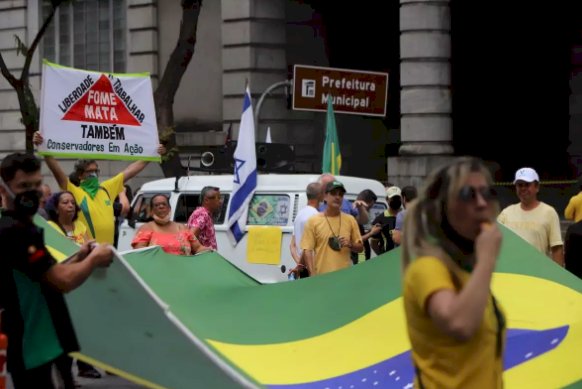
[403,257,505,389]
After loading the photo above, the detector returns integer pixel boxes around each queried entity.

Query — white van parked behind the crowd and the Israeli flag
[118,174,387,283]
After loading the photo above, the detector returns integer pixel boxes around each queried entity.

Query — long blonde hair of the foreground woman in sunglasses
[401,157,499,271]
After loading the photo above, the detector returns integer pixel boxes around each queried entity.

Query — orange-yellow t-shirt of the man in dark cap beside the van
[301,212,362,275]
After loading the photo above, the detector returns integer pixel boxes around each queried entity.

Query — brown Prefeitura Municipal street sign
[293,65,388,116]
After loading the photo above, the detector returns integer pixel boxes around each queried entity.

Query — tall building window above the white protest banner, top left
[42,0,127,73]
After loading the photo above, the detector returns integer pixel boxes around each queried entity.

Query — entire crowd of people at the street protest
[0,133,582,389]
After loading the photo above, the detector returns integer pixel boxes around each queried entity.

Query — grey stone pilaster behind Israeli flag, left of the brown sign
[221,0,288,143]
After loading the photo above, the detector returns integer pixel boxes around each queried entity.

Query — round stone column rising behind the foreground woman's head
[388,0,453,185]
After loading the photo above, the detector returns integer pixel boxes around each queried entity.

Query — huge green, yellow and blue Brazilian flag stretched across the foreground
[39,214,582,389]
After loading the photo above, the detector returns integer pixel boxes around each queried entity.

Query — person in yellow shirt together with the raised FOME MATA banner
[33,60,164,244]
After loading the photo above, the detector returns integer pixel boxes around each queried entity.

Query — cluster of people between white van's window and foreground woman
[289,173,416,279]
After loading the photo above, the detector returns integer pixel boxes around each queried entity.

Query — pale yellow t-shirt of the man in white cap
[497,202,563,255]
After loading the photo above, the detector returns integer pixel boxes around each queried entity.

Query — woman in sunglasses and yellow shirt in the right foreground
[402,157,505,388]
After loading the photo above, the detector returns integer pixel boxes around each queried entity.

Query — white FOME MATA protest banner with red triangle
[38,60,160,162]
